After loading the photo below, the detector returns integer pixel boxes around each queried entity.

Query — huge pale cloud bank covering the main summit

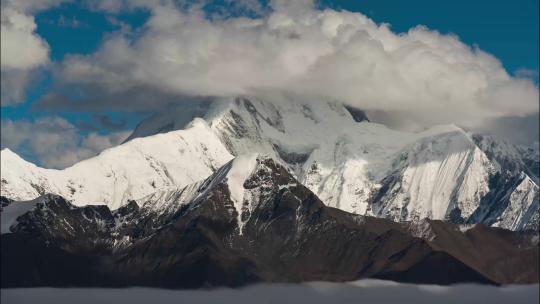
[53,0,538,125]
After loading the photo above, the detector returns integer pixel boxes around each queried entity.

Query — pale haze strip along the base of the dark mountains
[1,280,539,304]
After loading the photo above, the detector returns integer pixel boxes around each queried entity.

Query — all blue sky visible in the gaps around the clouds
[1,0,539,166]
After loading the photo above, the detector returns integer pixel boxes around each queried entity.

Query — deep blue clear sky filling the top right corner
[328,0,539,72]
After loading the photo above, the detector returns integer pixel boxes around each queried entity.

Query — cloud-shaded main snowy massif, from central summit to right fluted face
[200,98,538,227]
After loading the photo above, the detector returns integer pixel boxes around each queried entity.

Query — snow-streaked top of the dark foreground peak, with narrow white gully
[135,153,286,235]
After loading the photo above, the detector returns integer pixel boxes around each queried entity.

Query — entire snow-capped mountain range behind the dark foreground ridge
[1,97,538,229]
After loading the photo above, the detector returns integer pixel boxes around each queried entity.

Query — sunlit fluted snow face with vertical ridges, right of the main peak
[372,128,493,223]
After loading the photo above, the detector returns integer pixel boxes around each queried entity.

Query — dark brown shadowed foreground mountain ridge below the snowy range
[1,156,538,288]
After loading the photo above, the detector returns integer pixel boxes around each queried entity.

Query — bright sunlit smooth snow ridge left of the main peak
[0,119,232,209]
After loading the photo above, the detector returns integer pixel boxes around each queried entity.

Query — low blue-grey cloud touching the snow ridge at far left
[1,117,130,168]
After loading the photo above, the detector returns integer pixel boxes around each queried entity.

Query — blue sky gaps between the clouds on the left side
[2,3,149,133]
